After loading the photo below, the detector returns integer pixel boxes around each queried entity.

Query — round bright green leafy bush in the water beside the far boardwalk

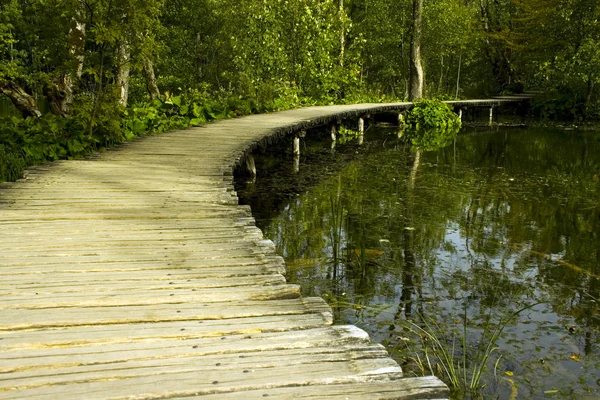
[405,100,461,150]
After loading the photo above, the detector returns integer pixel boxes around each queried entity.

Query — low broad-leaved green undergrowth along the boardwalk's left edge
[0,87,406,182]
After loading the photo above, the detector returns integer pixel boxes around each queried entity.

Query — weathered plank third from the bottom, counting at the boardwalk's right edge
[0,344,394,386]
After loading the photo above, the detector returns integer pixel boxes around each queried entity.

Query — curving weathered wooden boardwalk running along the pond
[0,99,528,400]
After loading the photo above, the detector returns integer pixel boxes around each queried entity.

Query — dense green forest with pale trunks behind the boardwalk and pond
[0,0,600,177]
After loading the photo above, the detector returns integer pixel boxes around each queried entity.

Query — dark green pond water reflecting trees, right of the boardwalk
[238,128,600,399]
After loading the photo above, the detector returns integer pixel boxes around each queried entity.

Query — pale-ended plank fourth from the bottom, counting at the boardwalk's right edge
[0,320,376,373]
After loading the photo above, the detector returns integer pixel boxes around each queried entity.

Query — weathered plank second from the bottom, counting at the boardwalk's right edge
[0,356,401,400]
